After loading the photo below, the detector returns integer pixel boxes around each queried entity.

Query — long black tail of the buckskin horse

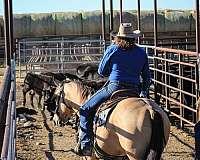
[146,111,166,160]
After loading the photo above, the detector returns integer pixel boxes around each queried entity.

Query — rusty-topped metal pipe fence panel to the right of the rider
[141,45,199,127]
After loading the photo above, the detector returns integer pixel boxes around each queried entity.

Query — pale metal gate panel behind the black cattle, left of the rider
[18,38,105,77]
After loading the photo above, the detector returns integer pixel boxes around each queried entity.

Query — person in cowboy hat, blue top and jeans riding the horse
[75,23,151,156]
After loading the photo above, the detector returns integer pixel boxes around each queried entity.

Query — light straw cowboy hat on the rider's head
[111,23,141,39]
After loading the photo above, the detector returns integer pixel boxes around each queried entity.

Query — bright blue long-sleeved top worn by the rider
[98,44,151,91]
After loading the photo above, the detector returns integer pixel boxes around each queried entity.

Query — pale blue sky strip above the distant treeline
[0,0,196,15]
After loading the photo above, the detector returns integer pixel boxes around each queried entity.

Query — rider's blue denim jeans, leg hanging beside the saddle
[79,82,139,148]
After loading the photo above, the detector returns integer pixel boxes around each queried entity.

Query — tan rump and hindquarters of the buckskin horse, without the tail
[96,98,169,158]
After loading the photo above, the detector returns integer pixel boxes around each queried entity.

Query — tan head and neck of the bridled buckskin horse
[54,79,93,125]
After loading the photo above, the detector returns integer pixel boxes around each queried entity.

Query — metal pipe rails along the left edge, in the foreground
[0,60,16,160]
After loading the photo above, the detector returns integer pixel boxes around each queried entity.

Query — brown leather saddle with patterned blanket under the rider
[94,89,139,128]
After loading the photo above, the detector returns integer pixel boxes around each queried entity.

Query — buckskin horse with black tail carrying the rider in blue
[51,80,170,160]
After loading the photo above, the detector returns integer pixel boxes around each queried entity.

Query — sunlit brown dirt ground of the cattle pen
[16,83,194,160]
